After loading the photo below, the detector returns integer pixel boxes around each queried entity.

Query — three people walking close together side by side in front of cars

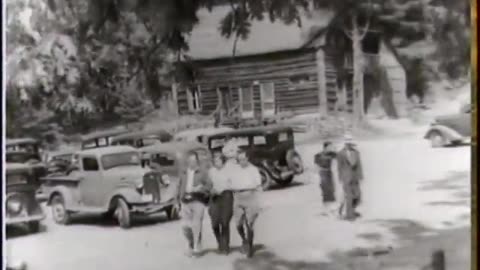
[181,140,262,257]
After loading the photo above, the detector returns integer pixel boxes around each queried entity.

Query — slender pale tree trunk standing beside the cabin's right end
[352,14,367,124]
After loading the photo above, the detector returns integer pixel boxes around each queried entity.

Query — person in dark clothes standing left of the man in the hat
[314,141,336,214]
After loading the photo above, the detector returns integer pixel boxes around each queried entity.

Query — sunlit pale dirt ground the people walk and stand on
[7,131,470,270]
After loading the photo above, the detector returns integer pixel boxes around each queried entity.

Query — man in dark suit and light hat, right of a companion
[337,135,363,220]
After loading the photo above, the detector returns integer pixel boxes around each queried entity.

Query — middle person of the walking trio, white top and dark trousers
[208,152,233,255]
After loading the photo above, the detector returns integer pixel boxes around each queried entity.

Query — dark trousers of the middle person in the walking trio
[208,191,233,252]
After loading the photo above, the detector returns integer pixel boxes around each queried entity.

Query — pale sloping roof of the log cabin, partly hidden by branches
[187,6,334,60]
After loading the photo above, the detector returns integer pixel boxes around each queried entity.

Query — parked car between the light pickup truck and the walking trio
[139,142,209,215]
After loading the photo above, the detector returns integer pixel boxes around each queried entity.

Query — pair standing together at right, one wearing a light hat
[314,135,363,221]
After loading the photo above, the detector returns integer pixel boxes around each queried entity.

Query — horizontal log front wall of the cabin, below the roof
[177,49,319,115]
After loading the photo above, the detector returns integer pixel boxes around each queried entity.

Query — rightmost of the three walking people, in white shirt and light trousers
[232,150,262,258]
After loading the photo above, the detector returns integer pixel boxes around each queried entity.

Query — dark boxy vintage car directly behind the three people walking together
[208,126,303,189]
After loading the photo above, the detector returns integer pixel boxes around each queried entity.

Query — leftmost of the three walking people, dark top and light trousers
[180,152,212,257]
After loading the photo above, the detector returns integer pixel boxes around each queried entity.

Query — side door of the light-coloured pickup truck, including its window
[79,156,104,207]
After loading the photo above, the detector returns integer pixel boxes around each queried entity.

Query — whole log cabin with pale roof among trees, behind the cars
[172,7,406,124]
